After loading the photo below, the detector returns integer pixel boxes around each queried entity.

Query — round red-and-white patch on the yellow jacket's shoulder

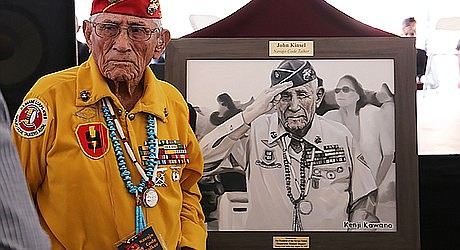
[13,98,48,138]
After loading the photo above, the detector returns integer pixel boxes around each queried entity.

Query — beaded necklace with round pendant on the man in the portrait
[282,138,315,231]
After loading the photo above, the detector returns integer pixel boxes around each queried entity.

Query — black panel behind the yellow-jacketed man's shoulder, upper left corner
[0,0,76,118]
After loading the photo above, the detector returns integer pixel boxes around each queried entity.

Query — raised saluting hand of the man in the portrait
[243,82,293,124]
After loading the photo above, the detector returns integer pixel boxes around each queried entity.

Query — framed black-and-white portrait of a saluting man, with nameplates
[165,37,420,249]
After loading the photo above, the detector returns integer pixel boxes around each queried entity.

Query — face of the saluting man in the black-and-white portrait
[277,80,324,137]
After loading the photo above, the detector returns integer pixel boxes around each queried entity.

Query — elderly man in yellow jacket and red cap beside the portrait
[12,0,206,249]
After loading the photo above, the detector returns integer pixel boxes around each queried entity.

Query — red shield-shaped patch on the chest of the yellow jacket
[75,123,110,160]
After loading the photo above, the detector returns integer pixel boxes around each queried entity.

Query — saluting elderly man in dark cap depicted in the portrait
[200,60,377,231]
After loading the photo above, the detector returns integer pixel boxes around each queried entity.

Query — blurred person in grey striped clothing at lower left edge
[0,89,51,250]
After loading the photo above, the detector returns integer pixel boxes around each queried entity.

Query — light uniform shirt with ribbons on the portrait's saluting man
[200,113,376,231]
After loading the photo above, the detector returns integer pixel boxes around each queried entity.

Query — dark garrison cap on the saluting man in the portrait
[271,60,318,87]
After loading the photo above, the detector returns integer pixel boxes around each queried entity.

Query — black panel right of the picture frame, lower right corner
[419,155,460,250]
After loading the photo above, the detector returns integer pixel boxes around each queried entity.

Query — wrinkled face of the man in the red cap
[85,13,169,82]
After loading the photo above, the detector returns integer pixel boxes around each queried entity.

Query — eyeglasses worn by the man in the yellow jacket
[91,22,161,41]
